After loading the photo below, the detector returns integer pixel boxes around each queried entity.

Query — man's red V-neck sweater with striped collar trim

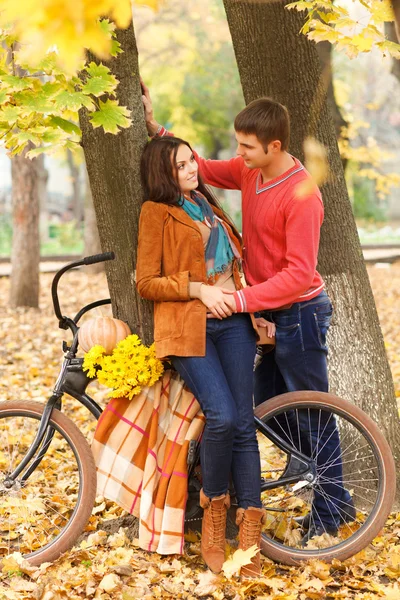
[195,153,324,312]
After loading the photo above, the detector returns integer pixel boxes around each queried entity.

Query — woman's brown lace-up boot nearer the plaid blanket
[200,490,231,573]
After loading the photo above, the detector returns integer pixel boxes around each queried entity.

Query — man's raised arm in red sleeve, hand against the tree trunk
[141,81,245,190]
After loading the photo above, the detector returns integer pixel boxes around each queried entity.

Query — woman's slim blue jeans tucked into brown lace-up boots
[171,314,262,509]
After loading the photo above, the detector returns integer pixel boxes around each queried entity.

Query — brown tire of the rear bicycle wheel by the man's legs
[254,391,396,565]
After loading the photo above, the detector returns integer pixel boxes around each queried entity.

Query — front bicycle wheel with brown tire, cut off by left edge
[0,401,96,565]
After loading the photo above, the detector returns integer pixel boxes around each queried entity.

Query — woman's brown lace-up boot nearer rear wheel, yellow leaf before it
[236,507,266,577]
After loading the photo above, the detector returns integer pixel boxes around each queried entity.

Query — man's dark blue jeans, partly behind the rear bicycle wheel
[254,292,350,527]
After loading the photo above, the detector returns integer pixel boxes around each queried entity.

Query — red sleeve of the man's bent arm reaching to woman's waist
[233,195,324,312]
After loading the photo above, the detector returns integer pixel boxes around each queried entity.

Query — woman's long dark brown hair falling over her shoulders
[140,135,222,210]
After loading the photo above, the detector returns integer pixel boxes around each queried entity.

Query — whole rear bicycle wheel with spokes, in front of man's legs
[255,391,396,565]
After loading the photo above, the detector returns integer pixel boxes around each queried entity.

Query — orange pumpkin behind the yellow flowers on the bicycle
[78,317,131,354]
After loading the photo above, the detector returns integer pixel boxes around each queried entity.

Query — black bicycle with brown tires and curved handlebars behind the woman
[0,253,396,565]
